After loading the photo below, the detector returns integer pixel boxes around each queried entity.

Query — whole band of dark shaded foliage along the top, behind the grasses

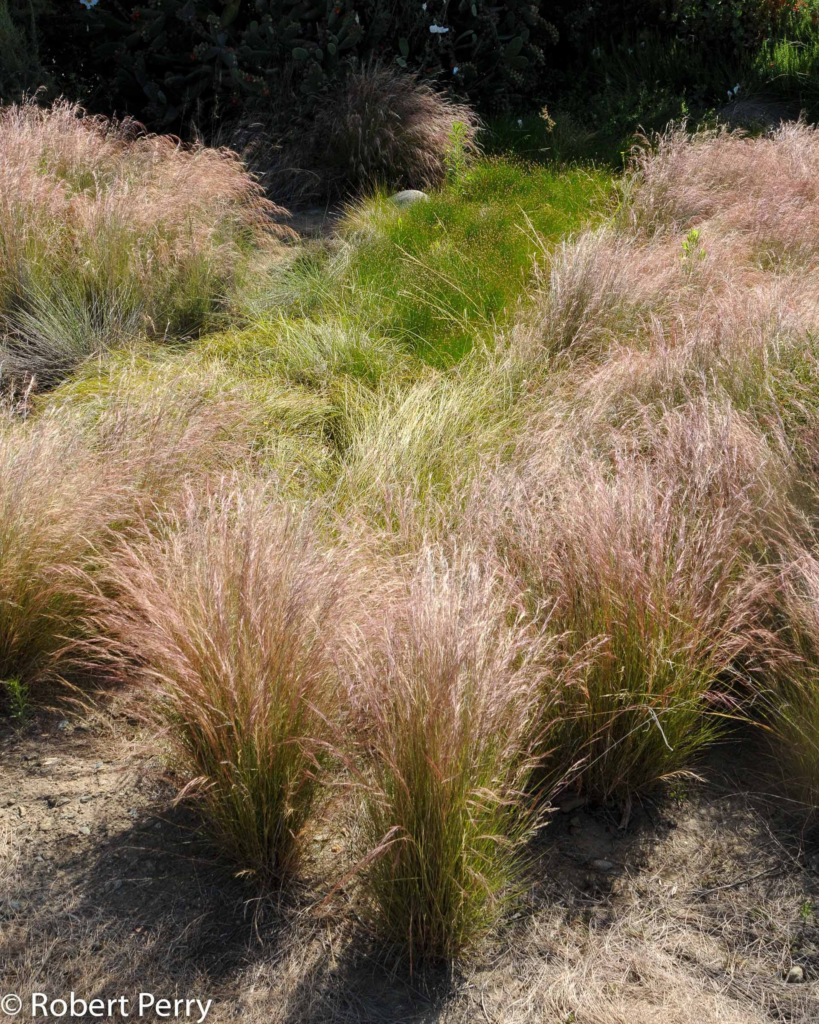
[0,0,819,155]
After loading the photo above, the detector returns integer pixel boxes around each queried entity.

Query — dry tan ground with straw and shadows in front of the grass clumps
[0,712,819,1024]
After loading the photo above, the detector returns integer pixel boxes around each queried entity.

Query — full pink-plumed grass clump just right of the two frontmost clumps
[495,407,787,798]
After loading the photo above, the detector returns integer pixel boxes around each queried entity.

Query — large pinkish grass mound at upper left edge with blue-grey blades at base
[0,100,288,385]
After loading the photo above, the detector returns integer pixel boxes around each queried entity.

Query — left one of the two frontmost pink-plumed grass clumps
[99,493,345,886]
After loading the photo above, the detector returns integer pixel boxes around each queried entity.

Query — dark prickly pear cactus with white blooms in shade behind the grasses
[77,0,555,125]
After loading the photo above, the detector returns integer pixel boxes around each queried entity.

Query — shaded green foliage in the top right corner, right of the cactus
[556,0,819,148]
